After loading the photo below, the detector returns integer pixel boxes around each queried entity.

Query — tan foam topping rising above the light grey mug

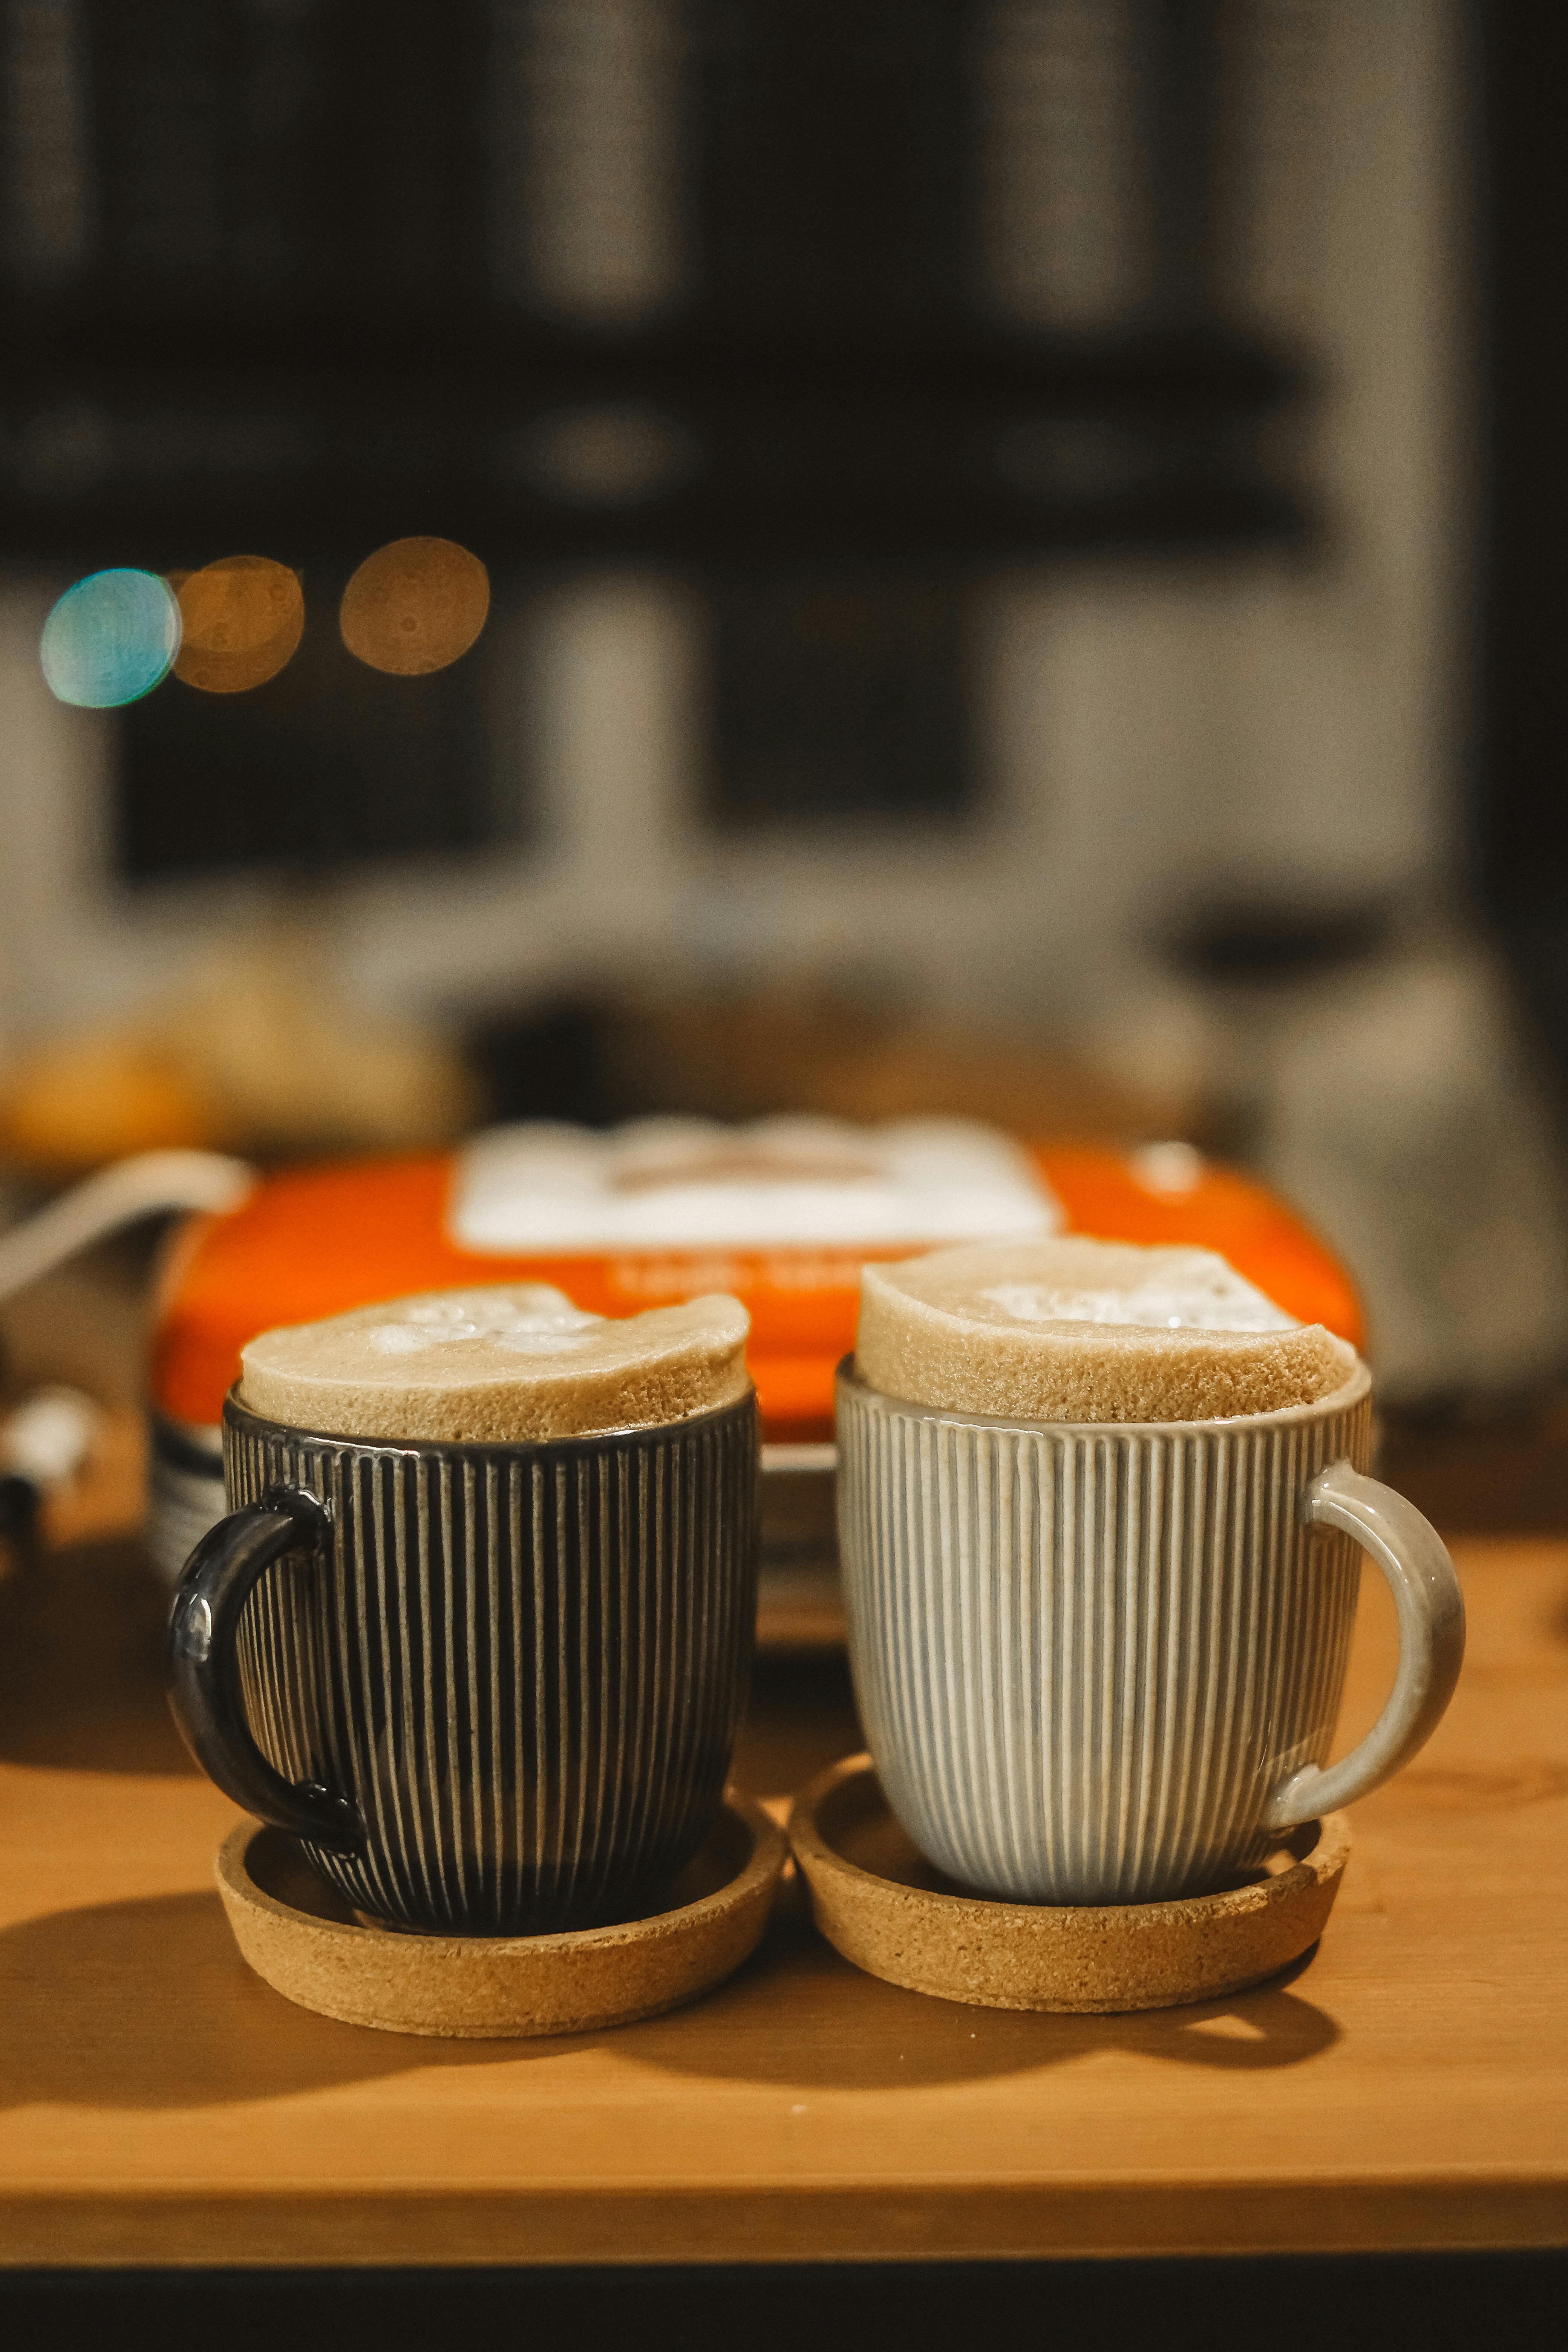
[856,1237,1357,1421]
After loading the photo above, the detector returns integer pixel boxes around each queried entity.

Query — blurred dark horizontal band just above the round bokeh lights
[0,313,1312,565]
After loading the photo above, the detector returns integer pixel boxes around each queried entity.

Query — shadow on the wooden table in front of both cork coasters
[0,1863,1335,2110]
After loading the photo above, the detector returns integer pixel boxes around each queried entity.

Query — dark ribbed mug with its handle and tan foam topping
[169,1284,757,1936]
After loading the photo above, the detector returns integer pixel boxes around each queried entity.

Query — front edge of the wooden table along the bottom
[0,2173,1568,2270]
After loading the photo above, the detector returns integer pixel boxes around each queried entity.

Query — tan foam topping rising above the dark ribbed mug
[240,1282,750,1444]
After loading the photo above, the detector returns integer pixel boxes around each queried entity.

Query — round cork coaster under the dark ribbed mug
[216,1790,790,2041]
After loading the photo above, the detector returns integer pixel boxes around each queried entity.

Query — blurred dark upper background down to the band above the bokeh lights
[0,0,1307,567]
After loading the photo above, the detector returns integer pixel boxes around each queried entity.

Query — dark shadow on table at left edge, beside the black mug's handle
[0,1538,195,1773]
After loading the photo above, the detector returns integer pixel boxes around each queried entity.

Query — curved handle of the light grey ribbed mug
[1262,1463,1465,1830]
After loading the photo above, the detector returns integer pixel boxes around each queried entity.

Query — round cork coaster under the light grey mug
[790,1757,1349,2011]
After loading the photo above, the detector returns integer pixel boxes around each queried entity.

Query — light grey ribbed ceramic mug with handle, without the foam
[837,1360,1465,1903]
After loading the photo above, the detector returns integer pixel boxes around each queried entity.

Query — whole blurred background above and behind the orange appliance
[0,0,1568,1416]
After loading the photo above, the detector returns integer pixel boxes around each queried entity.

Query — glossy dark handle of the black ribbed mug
[169,1487,364,1853]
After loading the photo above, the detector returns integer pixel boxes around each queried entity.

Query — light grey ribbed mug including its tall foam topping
[837,1239,1465,1903]
